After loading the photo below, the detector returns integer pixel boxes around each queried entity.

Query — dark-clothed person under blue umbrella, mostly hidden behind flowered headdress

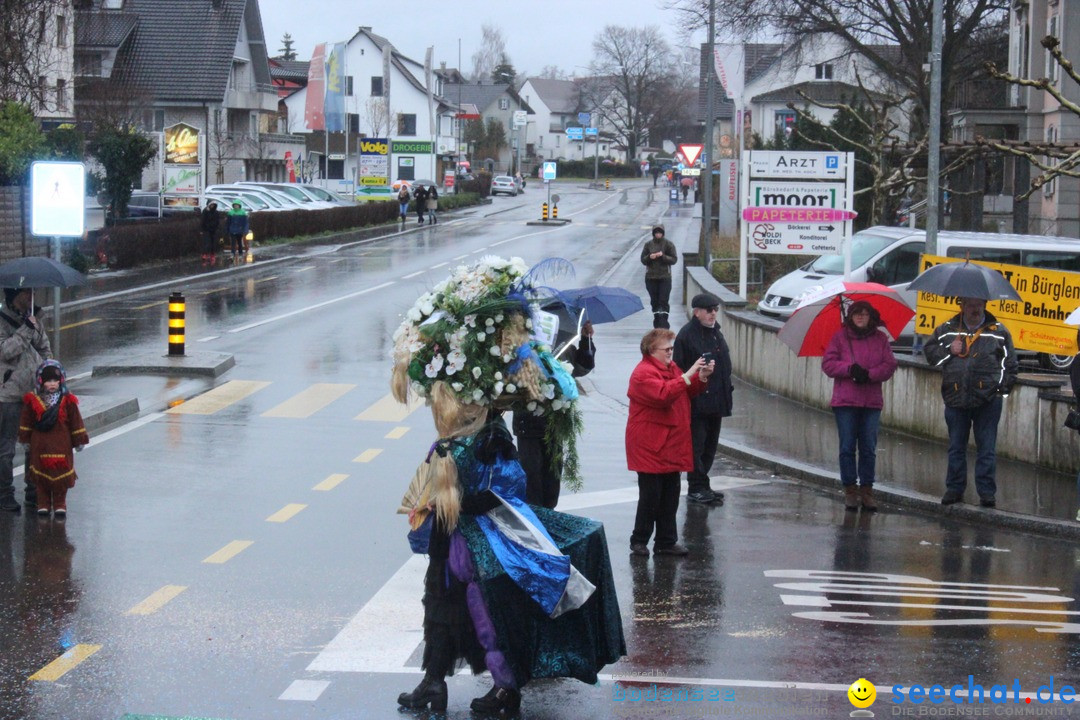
[513,322,596,510]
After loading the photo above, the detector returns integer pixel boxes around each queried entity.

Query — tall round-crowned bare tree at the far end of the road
[582,25,676,159]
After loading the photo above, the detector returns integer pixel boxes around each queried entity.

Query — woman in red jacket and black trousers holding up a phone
[626,328,715,556]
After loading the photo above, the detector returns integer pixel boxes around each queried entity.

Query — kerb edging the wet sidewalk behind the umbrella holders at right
[719,438,1080,541]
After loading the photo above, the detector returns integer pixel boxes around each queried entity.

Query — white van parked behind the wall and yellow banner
[757,226,1080,369]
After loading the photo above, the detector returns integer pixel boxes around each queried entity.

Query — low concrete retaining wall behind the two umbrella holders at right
[684,266,1080,472]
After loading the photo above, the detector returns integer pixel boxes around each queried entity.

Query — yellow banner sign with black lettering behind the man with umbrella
[915,255,1080,355]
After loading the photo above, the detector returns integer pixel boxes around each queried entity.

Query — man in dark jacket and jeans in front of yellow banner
[922,298,1018,507]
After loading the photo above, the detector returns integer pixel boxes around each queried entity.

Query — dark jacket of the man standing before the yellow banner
[922,312,1018,408]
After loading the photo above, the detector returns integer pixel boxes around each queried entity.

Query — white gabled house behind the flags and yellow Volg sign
[284,26,458,192]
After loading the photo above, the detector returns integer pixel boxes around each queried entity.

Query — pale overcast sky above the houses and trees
[259,0,700,74]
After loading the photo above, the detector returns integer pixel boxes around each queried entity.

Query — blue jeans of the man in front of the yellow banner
[945,397,1001,498]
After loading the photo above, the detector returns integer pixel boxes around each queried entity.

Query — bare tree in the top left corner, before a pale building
[0,0,75,110]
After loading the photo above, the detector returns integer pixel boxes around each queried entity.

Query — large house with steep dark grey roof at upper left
[75,0,295,192]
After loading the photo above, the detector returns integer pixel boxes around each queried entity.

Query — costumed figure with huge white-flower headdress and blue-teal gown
[391,257,625,715]
